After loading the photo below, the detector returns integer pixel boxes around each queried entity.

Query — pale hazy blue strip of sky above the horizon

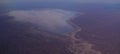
[0,0,120,3]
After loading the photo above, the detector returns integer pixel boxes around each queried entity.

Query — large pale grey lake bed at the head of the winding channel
[9,9,79,33]
